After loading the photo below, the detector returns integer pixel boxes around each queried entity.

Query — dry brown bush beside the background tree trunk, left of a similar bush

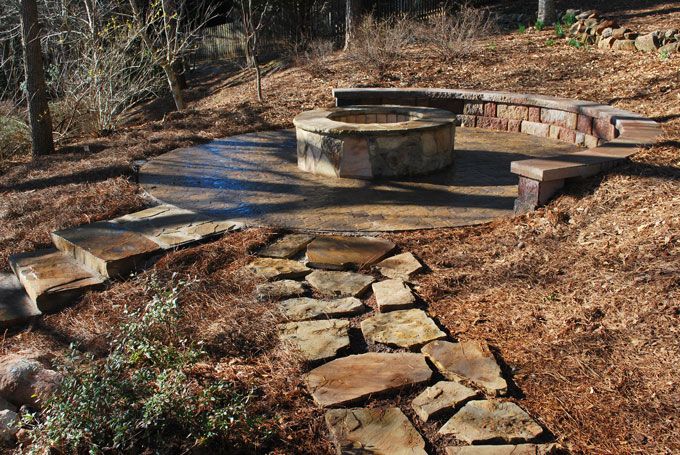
[347,14,410,76]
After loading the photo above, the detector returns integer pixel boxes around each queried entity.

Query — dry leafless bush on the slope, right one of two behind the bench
[417,4,495,60]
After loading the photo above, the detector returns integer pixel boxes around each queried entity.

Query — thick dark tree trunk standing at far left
[21,0,54,156]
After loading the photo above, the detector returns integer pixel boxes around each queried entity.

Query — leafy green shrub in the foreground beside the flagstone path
[27,280,266,453]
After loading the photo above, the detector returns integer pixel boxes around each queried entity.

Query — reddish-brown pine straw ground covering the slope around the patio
[0,1,680,454]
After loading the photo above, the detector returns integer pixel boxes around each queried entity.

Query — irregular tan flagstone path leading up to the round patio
[247,234,559,455]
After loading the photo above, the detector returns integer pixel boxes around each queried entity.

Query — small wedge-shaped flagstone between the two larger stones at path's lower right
[411,381,479,422]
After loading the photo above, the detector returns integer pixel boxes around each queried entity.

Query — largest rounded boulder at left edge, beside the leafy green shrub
[0,354,61,407]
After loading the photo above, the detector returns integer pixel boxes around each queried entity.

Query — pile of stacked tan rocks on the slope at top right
[565,10,680,54]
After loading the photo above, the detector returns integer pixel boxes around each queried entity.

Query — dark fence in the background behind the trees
[192,0,446,61]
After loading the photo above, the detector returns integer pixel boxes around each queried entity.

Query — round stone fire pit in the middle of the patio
[294,106,456,179]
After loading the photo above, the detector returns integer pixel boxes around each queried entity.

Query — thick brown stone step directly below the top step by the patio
[52,221,160,278]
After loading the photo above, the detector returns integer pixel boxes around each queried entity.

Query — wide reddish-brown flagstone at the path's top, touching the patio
[307,236,395,270]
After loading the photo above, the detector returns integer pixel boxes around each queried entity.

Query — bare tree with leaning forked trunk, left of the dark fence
[129,0,214,111]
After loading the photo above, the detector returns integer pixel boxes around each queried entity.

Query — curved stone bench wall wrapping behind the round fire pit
[333,88,662,214]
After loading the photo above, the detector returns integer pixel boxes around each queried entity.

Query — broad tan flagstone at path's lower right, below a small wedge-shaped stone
[439,400,543,444]
